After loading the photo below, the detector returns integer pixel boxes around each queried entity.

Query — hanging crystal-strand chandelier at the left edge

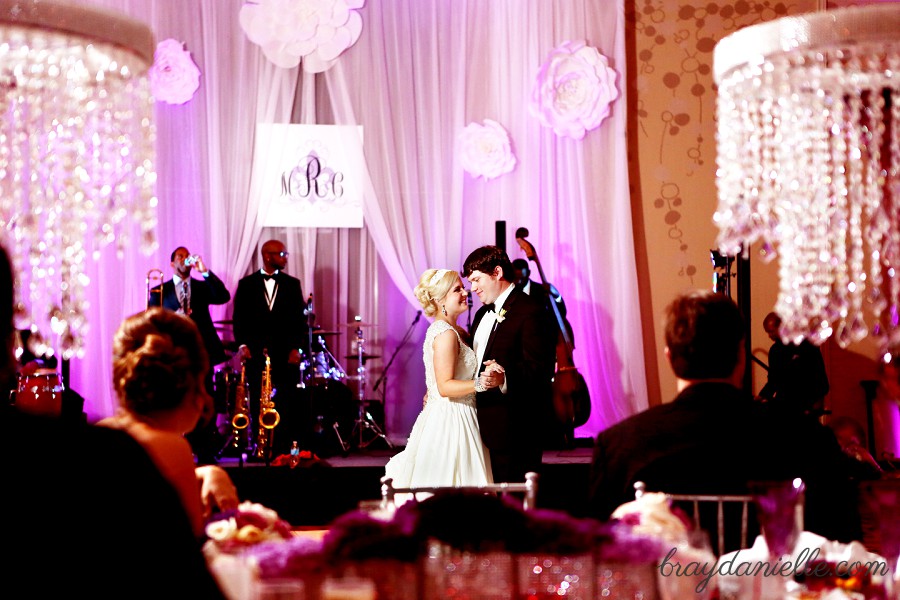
[0,0,156,359]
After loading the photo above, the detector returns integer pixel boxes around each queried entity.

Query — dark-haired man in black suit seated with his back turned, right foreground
[590,292,860,541]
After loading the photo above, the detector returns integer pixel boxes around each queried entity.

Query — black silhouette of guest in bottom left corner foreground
[0,243,225,599]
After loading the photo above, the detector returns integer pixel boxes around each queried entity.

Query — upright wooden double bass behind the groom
[516,227,591,446]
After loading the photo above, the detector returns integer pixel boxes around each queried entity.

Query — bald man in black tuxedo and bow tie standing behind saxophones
[232,240,308,451]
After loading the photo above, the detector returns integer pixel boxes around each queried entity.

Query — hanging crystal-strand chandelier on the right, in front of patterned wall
[713,3,900,352]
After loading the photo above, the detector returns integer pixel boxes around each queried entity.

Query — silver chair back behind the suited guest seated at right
[634,481,758,556]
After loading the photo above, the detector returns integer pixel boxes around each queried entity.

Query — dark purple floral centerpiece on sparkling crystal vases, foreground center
[323,490,662,598]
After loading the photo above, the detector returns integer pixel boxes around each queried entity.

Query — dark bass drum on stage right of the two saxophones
[305,380,359,458]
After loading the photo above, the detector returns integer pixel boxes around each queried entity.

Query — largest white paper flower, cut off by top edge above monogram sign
[240,0,365,73]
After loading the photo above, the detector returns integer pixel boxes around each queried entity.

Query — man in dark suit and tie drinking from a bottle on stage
[160,246,231,464]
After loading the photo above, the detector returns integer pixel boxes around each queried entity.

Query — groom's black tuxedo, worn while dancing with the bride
[470,288,556,481]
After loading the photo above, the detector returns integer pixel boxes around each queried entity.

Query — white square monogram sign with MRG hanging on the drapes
[251,124,366,227]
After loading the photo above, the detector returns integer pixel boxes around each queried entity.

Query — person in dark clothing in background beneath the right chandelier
[759,312,829,413]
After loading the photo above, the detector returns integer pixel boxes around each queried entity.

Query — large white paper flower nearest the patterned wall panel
[529,41,619,140]
